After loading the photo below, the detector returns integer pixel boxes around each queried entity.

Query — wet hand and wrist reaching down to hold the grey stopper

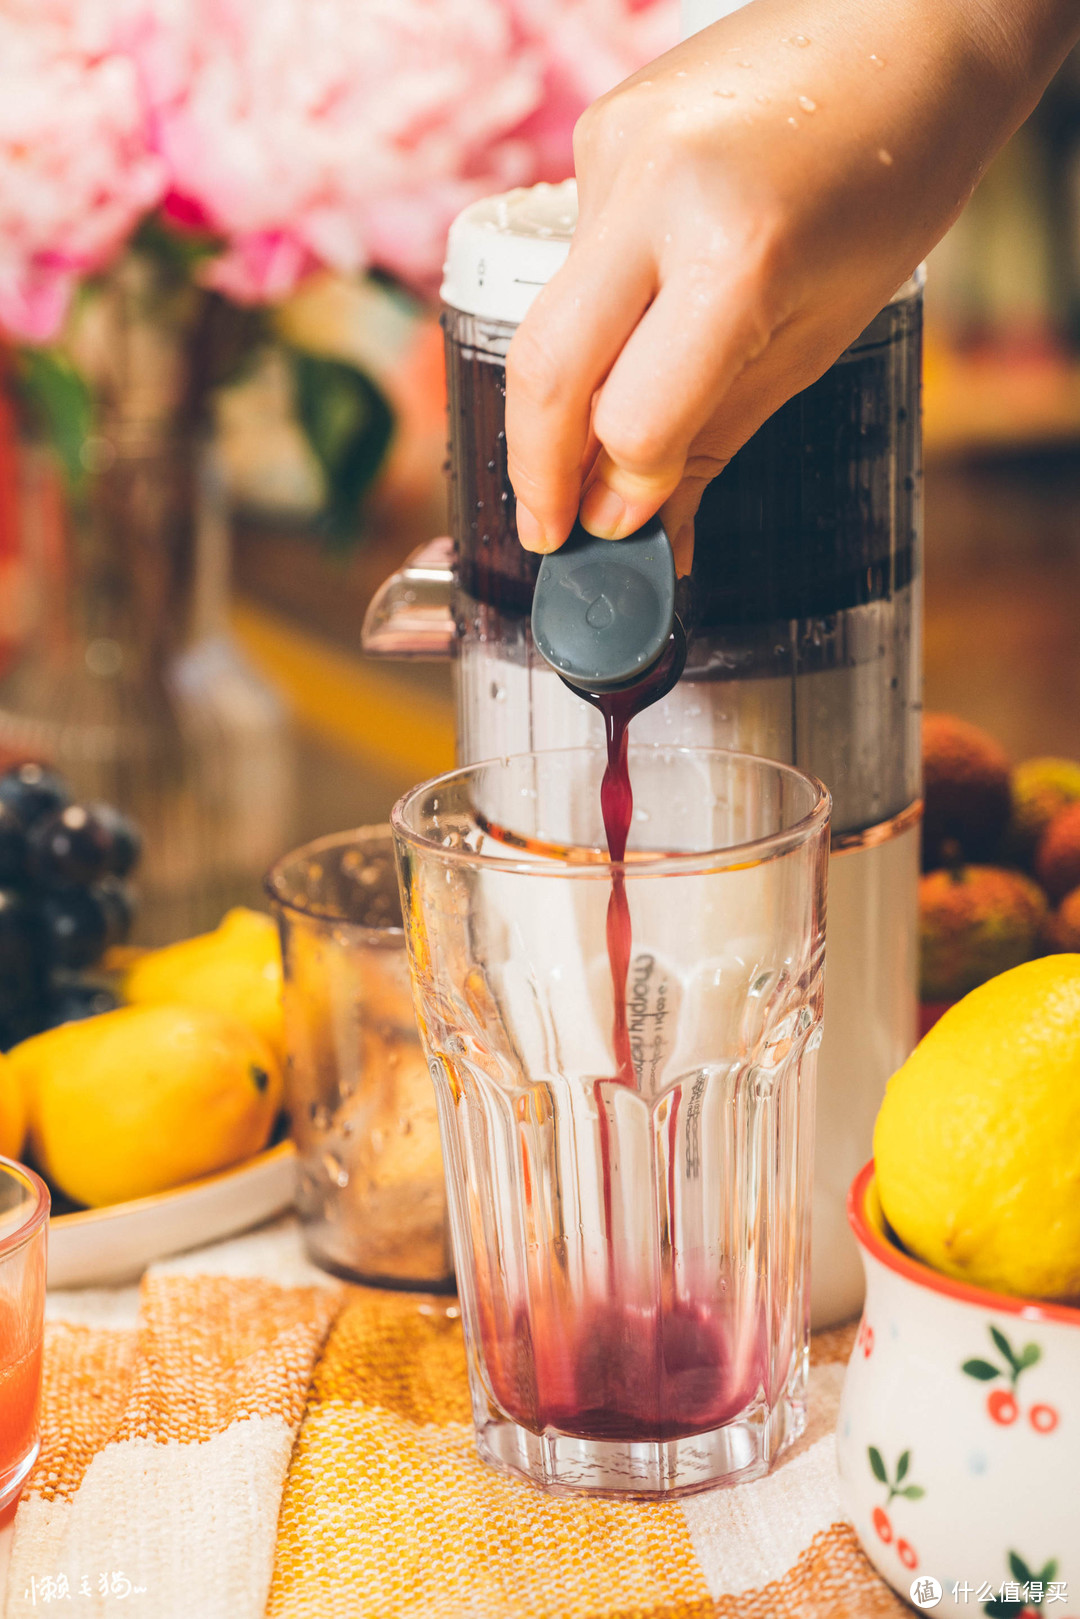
[507,0,1080,573]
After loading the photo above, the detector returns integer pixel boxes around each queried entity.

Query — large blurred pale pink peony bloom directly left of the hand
[134,0,675,301]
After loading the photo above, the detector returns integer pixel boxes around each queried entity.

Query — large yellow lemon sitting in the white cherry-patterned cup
[874,955,1080,1298]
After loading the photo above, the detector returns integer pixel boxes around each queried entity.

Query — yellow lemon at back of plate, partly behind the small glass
[123,908,285,1057]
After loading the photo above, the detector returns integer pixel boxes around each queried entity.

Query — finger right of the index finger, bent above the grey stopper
[581,267,772,539]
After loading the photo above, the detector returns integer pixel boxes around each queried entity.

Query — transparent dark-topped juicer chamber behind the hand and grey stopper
[444,296,921,837]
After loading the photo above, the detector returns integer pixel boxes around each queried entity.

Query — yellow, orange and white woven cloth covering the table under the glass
[0,1222,907,1619]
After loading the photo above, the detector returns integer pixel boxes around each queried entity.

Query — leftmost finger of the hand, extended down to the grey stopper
[507,228,654,552]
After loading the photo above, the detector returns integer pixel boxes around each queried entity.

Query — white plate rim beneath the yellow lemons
[49,1141,296,1287]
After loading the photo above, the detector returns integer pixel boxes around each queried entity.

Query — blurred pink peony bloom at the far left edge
[0,0,167,343]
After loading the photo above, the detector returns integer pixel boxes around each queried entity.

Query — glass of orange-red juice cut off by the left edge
[0,1158,49,1511]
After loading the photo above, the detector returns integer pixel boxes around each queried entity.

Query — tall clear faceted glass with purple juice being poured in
[392,746,829,1496]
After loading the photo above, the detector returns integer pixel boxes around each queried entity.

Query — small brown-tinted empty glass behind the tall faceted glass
[267,826,453,1290]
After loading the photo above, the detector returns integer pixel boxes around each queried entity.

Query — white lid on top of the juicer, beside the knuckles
[442,180,578,325]
